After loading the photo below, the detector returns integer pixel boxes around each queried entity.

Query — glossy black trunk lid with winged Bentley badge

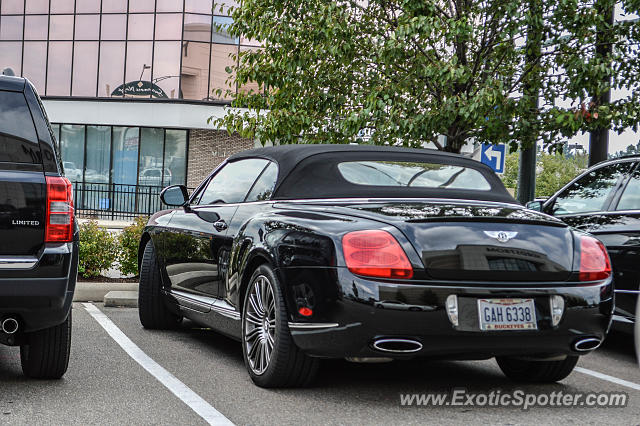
[351,202,573,281]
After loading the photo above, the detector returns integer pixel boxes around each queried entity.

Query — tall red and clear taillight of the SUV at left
[44,176,73,243]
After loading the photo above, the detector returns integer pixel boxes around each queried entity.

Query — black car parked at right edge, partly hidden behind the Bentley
[528,156,640,333]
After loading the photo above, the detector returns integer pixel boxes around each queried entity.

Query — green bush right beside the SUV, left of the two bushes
[78,220,118,278]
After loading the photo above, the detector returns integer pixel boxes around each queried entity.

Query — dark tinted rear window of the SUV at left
[0,91,41,163]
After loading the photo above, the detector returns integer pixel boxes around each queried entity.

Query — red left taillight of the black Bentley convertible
[342,230,413,279]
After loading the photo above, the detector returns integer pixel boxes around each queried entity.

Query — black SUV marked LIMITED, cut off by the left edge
[0,75,78,379]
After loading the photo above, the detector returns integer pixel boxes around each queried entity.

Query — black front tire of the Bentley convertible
[138,240,182,330]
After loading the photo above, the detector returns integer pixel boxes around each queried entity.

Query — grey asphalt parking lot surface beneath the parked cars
[0,303,640,425]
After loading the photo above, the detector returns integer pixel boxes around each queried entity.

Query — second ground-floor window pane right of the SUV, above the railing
[84,126,111,183]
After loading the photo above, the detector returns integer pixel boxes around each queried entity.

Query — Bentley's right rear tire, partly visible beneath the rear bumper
[496,356,579,383]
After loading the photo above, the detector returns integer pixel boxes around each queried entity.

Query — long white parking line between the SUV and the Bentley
[83,303,233,425]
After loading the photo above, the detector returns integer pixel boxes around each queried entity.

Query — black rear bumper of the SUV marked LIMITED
[0,242,78,333]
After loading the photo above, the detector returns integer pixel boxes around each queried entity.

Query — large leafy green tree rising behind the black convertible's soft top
[210,0,640,152]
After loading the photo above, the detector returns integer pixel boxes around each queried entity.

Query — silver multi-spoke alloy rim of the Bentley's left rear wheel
[243,275,276,375]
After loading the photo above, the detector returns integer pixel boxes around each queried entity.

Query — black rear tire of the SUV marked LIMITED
[20,311,72,379]
